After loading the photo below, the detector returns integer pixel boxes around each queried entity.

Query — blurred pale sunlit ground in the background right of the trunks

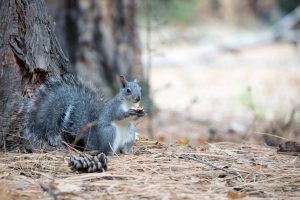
[140,25,300,145]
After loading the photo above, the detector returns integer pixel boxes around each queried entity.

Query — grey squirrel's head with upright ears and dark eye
[120,76,142,103]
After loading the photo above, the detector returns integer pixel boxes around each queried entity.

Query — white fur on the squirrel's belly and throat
[112,102,139,152]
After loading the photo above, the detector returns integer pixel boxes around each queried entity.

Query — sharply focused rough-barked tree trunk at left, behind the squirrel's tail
[0,0,69,150]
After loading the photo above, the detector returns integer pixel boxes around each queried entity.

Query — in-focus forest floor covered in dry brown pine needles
[0,139,300,200]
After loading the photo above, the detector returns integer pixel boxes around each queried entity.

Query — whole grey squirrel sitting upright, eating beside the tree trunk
[23,75,145,155]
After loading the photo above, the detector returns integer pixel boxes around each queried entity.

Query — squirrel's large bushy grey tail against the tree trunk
[24,75,104,150]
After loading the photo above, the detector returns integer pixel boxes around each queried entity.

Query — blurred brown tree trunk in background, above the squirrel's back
[47,0,145,93]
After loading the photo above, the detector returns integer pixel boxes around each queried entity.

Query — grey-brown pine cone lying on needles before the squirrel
[67,153,107,173]
